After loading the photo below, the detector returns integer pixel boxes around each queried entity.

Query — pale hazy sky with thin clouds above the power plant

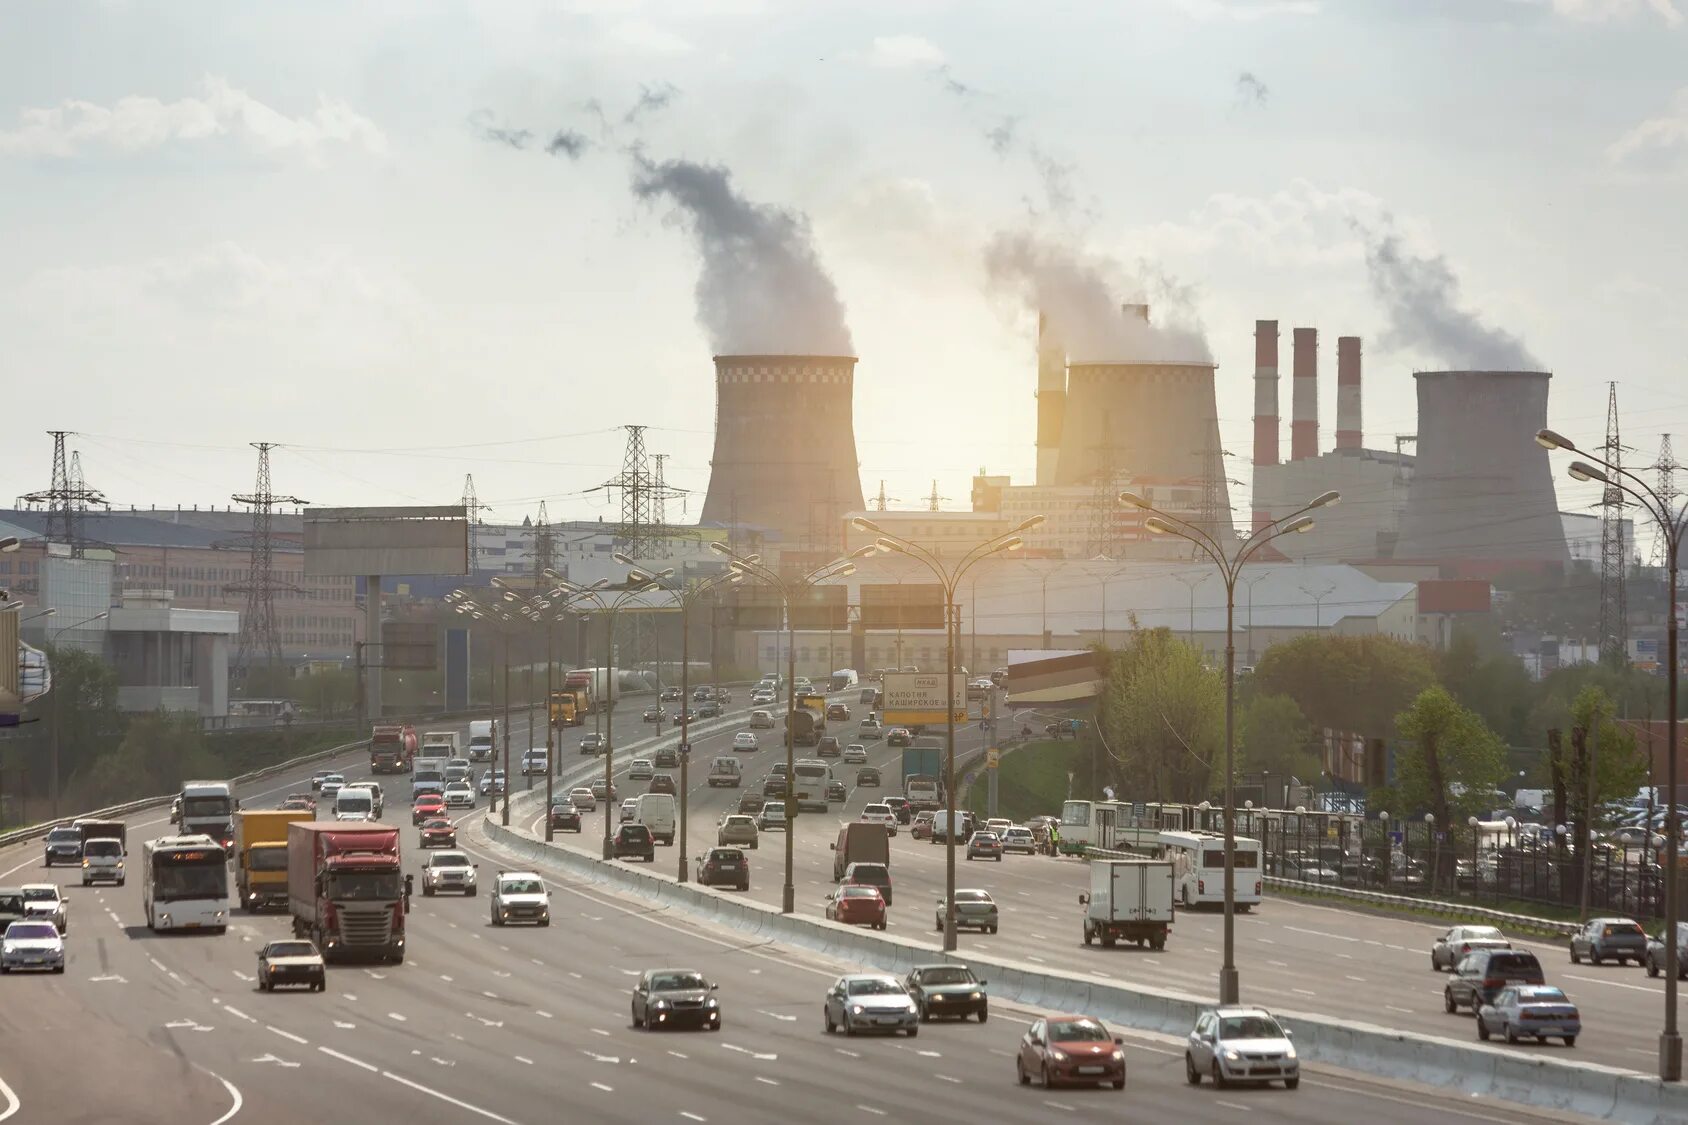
[0,0,1688,522]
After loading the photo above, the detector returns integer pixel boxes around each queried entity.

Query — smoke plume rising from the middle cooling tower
[984,231,1212,363]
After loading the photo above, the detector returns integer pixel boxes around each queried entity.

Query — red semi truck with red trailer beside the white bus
[287,821,408,965]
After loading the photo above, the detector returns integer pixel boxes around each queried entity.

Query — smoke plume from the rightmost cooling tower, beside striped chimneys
[1355,225,1545,372]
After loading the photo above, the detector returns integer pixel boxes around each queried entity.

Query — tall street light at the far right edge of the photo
[1536,429,1688,1083]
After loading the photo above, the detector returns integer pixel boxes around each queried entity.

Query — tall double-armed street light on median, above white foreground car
[1119,492,1342,1003]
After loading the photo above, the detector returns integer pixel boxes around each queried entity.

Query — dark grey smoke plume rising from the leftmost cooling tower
[633,157,854,355]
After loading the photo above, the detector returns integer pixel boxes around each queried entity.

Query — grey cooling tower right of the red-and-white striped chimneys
[1394,372,1568,566]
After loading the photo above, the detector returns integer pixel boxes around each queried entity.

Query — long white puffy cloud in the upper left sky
[0,74,387,159]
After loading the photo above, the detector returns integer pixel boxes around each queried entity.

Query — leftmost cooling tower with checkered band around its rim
[702,355,863,544]
